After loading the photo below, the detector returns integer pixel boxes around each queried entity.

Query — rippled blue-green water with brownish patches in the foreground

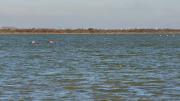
[0,35,180,101]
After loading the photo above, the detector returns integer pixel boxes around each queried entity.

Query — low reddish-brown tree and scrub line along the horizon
[0,28,180,33]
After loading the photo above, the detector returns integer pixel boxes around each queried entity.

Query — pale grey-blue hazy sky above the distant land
[0,0,180,28]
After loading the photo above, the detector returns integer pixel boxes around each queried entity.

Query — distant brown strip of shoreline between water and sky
[0,28,180,35]
